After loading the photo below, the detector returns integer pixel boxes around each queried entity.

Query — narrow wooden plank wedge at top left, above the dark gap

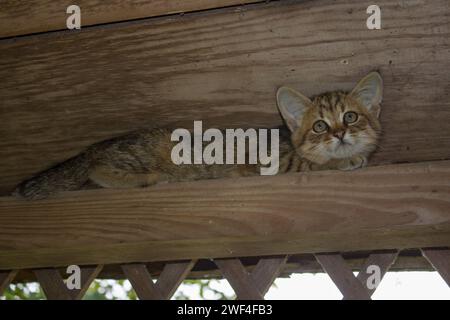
[0,0,264,38]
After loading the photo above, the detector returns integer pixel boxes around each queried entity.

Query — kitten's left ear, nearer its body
[277,87,311,132]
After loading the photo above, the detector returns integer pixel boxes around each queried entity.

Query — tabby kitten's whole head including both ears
[277,72,382,164]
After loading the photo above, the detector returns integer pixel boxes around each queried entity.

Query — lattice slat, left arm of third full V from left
[214,259,264,300]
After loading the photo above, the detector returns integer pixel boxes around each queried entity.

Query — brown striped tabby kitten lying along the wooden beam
[14,72,382,199]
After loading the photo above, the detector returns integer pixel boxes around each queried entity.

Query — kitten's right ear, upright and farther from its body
[350,72,383,118]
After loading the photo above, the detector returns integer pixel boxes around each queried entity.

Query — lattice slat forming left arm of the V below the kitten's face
[316,254,370,300]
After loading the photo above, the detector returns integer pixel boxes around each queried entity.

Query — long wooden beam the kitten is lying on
[0,161,450,270]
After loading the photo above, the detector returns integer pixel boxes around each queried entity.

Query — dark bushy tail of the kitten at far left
[13,152,92,200]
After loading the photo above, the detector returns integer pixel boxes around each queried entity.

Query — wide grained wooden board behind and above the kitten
[0,0,450,194]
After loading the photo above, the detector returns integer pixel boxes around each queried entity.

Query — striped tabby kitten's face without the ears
[292,92,380,163]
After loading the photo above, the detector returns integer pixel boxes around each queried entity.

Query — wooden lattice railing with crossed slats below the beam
[0,248,450,300]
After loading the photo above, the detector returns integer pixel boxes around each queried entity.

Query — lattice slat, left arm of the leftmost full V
[34,268,73,300]
